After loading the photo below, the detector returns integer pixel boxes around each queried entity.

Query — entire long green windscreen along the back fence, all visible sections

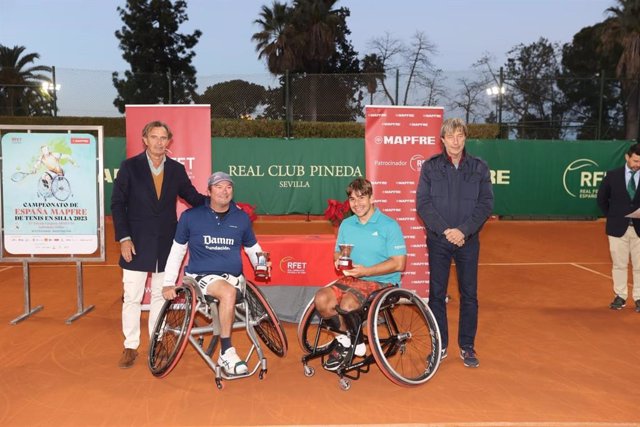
[104,138,631,217]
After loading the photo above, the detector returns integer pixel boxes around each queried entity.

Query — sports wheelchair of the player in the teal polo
[297,285,442,391]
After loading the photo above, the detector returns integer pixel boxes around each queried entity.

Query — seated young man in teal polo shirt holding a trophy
[314,178,407,370]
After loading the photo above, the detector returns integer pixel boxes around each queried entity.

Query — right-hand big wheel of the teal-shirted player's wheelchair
[367,288,442,386]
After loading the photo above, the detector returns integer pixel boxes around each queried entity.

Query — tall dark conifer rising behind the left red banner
[112,0,202,113]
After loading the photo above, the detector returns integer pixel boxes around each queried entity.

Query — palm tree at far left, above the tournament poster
[0,45,51,116]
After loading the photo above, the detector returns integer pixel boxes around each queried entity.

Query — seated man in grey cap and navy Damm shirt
[162,172,262,375]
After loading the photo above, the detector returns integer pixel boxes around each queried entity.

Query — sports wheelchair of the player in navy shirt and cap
[148,276,287,389]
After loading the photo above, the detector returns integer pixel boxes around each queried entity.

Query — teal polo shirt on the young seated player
[335,208,407,284]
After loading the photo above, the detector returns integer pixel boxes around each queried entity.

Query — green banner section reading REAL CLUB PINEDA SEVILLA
[213,138,365,215]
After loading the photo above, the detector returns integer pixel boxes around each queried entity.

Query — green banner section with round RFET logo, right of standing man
[467,140,632,217]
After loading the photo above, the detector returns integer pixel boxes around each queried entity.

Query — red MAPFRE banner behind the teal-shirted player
[365,105,444,297]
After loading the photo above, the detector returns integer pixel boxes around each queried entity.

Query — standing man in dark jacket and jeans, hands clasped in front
[416,118,493,368]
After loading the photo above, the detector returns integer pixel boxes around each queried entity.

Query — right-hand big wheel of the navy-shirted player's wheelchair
[245,280,288,357]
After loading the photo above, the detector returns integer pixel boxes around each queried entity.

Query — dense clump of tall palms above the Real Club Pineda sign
[252,0,364,121]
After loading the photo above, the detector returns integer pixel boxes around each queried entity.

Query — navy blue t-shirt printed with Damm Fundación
[175,201,258,276]
